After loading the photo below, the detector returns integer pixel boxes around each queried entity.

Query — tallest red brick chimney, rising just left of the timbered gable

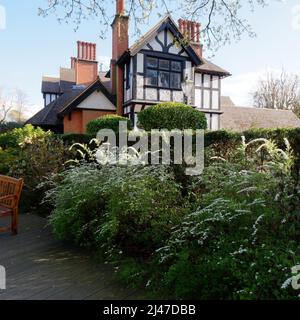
[110,0,129,115]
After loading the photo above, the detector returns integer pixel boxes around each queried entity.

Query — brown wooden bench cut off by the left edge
[0,175,24,234]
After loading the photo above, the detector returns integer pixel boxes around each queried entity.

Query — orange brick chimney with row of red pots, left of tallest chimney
[71,41,98,85]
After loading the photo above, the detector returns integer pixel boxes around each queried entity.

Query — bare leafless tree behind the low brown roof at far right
[252,70,300,117]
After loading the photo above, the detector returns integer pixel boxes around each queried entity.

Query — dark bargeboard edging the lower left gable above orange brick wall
[59,77,116,117]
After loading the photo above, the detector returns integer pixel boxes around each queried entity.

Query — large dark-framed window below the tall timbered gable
[146,57,182,90]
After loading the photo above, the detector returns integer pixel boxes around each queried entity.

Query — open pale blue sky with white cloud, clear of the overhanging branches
[0,0,300,112]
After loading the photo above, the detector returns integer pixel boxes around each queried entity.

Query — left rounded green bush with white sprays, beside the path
[48,164,183,256]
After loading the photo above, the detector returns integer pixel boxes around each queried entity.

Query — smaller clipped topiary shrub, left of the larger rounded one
[86,114,131,136]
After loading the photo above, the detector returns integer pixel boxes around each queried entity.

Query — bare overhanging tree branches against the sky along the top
[39,0,270,50]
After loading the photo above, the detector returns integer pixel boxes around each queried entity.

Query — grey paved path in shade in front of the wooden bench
[0,215,141,300]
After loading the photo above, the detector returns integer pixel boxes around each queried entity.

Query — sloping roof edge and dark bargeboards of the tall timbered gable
[118,15,203,65]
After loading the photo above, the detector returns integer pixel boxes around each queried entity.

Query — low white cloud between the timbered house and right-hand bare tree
[222,68,280,106]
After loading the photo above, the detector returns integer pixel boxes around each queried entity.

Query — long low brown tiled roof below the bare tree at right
[220,105,300,132]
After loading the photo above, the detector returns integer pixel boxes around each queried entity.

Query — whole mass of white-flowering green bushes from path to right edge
[44,129,300,299]
